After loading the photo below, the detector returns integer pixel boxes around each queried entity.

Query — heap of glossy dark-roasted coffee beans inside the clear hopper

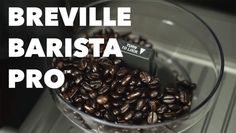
[52,28,196,124]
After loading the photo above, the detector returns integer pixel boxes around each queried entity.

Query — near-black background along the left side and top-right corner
[0,0,236,128]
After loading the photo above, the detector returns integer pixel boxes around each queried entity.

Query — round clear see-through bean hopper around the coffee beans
[51,0,224,133]
